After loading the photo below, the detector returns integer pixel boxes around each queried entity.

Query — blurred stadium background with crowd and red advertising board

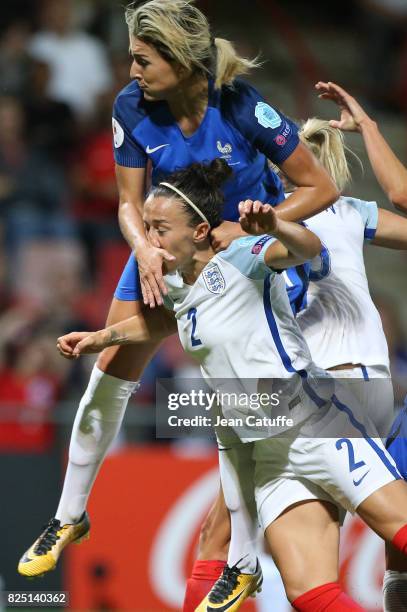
[0,0,407,612]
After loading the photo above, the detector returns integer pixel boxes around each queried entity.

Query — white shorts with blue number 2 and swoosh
[253,400,400,529]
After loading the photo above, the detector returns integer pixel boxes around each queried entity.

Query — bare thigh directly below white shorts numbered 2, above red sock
[265,500,339,601]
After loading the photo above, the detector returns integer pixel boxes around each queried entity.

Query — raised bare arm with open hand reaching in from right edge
[315,81,407,212]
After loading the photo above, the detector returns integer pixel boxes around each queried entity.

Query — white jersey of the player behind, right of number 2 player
[297,197,389,368]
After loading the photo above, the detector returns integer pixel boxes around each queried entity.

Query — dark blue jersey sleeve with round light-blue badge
[225,80,299,165]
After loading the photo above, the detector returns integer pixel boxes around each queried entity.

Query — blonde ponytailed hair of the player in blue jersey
[125,0,260,89]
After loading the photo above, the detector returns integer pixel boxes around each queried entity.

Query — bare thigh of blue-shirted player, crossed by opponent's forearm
[97,298,169,380]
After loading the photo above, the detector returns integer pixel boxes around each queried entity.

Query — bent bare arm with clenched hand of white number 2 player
[239,200,322,269]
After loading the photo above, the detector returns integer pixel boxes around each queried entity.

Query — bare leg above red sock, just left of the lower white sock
[198,487,231,561]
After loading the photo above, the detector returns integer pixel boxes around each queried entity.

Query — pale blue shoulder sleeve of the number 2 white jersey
[218,234,276,280]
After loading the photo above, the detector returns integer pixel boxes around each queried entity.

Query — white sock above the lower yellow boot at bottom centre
[219,444,258,574]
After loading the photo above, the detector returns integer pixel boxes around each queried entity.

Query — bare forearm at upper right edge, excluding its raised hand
[359,120,407,212]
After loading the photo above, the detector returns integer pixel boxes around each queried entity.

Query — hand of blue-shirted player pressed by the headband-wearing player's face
[137,245,175,308]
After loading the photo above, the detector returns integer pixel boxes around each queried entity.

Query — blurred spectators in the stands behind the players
[0,0,407,450]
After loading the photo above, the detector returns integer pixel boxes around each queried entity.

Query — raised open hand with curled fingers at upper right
[315,81,371,132]
